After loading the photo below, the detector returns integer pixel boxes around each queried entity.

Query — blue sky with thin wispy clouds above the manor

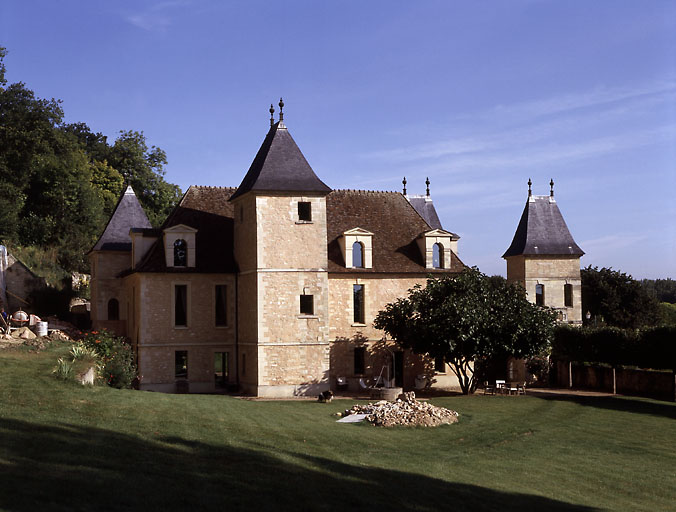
[0,0,676,278]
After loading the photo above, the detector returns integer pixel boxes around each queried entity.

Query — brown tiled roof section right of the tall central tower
[326,190,464,274]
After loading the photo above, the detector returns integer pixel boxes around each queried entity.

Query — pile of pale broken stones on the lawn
[342,391,458,427]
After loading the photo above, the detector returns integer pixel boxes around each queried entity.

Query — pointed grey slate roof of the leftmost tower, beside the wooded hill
[92,186,152,251]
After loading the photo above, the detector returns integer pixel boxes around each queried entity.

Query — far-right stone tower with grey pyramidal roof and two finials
[502,179,584,324]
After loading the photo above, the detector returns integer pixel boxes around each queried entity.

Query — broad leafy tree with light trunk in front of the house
[374,268,556,394]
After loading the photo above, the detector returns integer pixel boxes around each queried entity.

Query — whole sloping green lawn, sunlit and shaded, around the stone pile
[0,346,676,511]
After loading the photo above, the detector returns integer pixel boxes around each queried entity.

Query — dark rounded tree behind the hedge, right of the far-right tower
[580,265,661,329]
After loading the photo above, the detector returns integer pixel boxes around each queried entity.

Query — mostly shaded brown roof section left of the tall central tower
[132,186,237,273]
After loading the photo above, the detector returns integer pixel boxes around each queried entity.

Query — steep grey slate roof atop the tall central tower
[230,123,331,200]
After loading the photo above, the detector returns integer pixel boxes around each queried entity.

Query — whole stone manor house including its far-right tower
[89,102,581,396]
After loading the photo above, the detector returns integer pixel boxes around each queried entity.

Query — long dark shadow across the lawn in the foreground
[0,419,592,512]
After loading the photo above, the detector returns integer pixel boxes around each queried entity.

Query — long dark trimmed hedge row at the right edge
[552,325,676,369]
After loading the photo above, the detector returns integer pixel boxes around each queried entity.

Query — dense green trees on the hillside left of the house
[0,47,181,271]
